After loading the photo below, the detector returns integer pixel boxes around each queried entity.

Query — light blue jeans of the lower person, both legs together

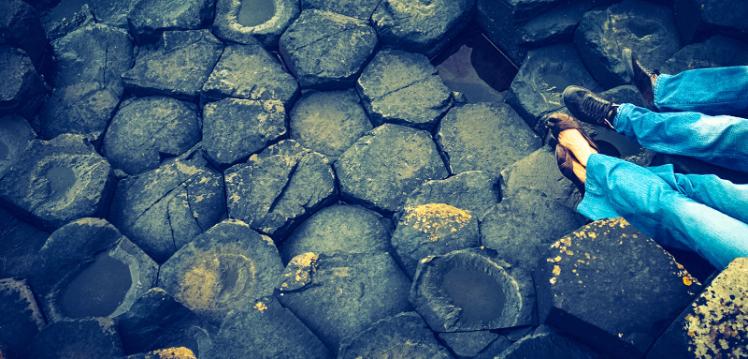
[577,154,748,268]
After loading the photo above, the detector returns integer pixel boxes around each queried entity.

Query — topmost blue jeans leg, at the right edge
[654,66,748,116]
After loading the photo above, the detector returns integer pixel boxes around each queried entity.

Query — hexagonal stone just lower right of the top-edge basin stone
[280,10,377,88]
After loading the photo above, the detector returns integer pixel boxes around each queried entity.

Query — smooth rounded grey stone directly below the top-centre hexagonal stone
[290,90,372,161]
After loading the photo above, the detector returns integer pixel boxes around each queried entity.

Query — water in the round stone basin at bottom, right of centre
[441,266,504,323]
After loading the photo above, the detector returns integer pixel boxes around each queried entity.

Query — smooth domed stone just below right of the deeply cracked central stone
[280,205,391,261]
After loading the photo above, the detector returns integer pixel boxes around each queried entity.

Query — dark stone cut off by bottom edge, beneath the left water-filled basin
[28,318,124,359]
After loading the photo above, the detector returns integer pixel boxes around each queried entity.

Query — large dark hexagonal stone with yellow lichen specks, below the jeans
[534,219,700,357]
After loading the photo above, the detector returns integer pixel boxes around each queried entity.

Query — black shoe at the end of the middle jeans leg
[563,86,618,130]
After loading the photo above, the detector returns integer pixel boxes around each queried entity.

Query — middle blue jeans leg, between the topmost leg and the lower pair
[613,102,748,172]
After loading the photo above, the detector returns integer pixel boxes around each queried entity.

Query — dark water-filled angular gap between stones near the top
[432,27,518,103]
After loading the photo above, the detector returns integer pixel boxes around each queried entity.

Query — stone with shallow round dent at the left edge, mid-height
[0,135,114,228]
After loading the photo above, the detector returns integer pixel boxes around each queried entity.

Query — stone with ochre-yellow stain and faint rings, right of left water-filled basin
[158,220,283,324]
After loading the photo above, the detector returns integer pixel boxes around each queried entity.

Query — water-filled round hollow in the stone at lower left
[59,253,132,318]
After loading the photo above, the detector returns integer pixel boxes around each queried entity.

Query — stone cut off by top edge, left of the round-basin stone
[127,0,215,39]
